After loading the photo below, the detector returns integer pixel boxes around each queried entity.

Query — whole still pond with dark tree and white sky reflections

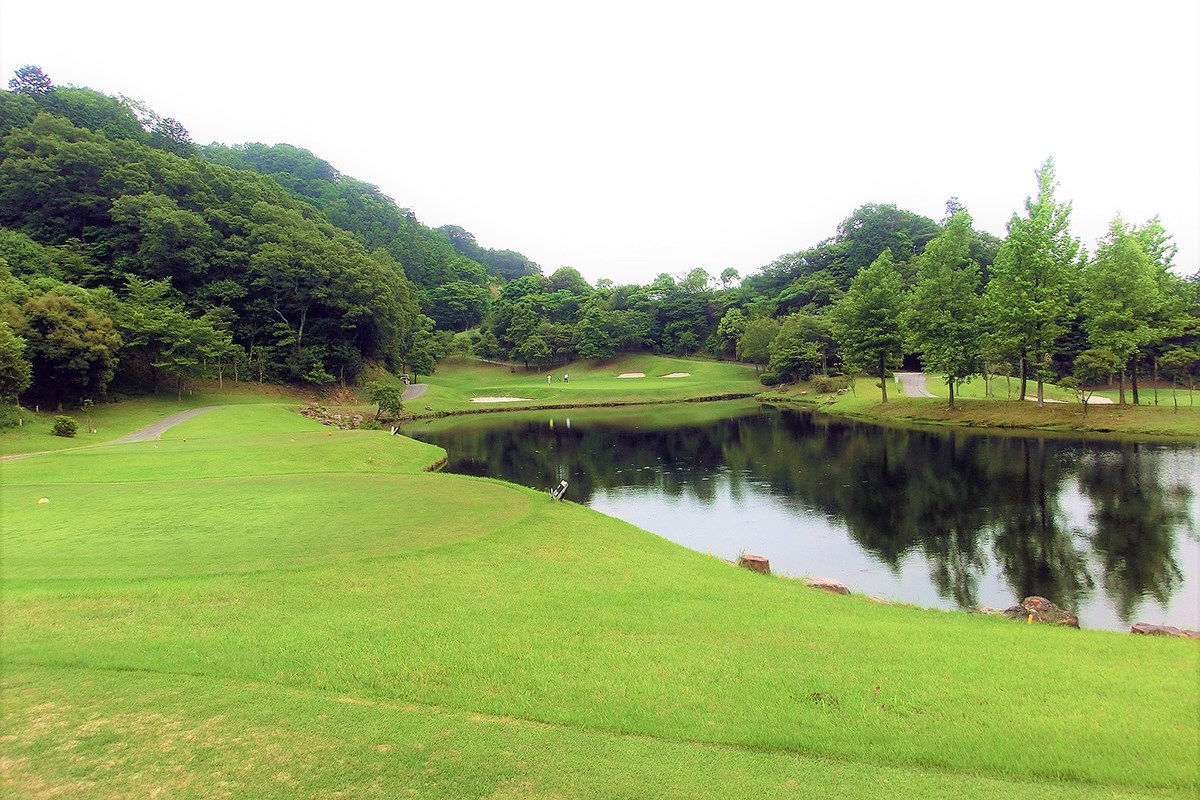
[404,402,1200,630]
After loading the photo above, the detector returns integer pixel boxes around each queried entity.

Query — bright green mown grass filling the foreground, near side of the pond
[0,398,1200,799]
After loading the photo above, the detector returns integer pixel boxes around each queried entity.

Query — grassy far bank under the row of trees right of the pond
[760,375,1200,439]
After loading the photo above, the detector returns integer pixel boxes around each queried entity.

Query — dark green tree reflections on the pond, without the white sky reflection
[407,403,1196,624]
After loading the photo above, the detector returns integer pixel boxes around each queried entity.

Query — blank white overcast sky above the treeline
[0,0,1200,283]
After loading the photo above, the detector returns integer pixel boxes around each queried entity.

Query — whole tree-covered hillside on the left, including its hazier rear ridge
[0,67,525,404]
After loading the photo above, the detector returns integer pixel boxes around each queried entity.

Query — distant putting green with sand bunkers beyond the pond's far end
[406,355,762,414]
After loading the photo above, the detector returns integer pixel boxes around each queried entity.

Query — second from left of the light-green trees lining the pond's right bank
[904,210,983,408]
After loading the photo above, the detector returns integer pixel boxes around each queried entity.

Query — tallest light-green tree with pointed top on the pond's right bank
[986,158,1079,405]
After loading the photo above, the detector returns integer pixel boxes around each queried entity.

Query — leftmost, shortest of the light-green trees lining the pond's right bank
[833,249,904,403]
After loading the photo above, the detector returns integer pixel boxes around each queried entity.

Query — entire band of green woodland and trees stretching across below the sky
[0,66,1200,405]
